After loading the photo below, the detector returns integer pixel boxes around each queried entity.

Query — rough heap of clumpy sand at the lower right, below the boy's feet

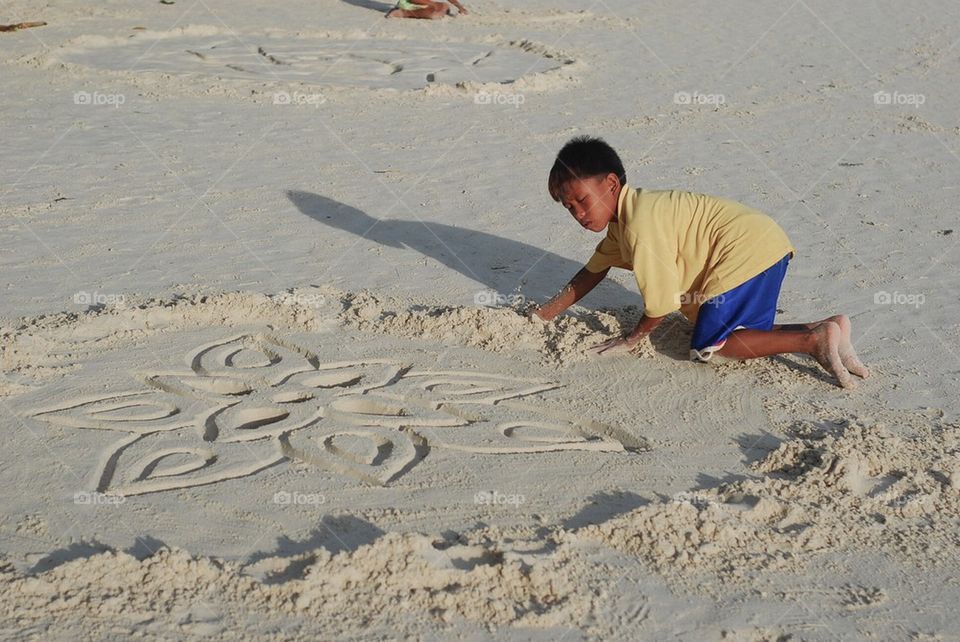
[585,418,960,582]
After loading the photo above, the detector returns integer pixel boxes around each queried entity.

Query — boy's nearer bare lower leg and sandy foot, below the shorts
[717,321,857,388]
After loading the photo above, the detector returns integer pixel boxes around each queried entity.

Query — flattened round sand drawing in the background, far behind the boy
[60,32,563,89]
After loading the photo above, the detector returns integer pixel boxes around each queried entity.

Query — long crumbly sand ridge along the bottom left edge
[0,531,589,635]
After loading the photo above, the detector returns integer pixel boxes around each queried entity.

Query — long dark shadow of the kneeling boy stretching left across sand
[287,190,640,306]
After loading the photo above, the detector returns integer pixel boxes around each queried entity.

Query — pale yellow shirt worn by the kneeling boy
[586,185,796,321]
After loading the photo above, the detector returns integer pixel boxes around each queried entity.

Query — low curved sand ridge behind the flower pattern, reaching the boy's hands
[0,289,653,388]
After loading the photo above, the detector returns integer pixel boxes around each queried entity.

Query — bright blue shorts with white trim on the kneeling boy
[690,254,790,361]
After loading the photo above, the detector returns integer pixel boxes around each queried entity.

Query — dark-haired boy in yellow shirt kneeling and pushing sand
[533,136,870,388]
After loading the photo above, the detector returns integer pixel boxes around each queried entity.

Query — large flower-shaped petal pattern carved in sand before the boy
[29,334,648,496]
